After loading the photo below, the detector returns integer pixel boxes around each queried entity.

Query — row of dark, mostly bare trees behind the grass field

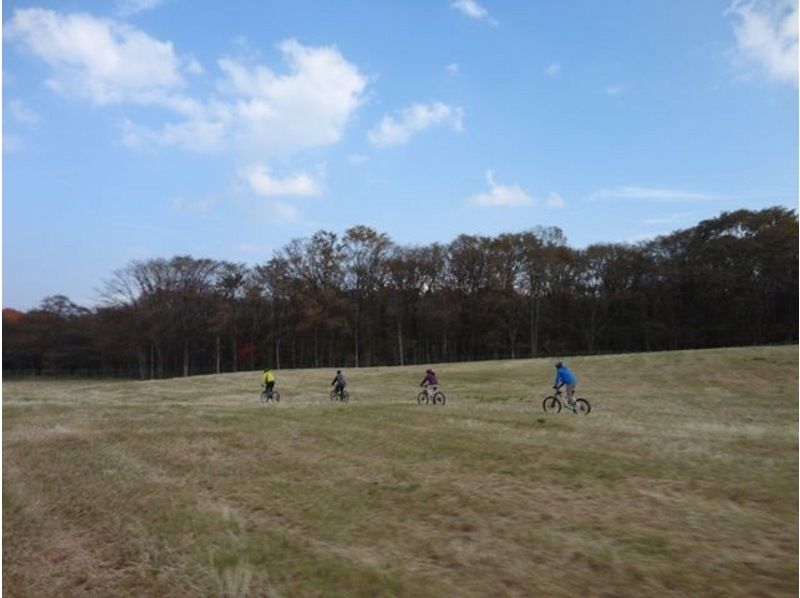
[3,207,798,379]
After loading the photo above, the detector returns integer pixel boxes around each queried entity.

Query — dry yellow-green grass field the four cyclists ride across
[3,346,798,597]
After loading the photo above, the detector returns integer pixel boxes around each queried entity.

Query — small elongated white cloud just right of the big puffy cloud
[367,102,464,147]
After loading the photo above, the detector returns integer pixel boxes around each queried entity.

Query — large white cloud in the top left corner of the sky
[5,8,199,105]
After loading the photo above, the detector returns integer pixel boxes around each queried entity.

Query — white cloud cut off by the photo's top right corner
[726,0,798,86]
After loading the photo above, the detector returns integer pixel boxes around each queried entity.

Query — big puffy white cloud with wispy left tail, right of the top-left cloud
[117,40,367,161]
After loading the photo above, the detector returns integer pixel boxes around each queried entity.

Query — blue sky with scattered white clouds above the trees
[2,0,798,310]
